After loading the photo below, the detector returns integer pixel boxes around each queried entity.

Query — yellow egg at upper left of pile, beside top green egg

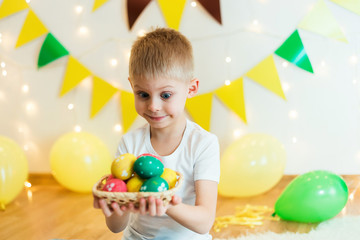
[111,153,136,180]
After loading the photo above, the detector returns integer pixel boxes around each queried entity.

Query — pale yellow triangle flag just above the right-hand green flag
[298,0,347,43]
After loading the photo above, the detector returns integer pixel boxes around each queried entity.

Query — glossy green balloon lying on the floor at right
[275,170,348,223]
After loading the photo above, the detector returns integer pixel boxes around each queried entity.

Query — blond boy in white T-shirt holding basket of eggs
[94,28,220,240]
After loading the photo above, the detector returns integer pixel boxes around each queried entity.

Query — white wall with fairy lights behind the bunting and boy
[0,0,360,174]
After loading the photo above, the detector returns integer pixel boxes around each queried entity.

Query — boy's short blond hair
[129,28,194,81]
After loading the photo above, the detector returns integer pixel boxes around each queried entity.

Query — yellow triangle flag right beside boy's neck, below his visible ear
[185,93,213,131]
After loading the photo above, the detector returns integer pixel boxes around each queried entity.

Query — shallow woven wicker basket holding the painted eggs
[92,172,183,208]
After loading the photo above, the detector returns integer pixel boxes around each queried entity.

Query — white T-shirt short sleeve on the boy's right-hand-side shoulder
[194,134,220,183]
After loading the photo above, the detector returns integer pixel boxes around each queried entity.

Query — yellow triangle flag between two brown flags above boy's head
[158,0,186,30]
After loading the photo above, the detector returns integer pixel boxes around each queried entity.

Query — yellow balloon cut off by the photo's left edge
[0,136,28,209]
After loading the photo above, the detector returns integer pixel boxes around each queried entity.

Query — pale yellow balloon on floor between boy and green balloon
[219,134,286,197]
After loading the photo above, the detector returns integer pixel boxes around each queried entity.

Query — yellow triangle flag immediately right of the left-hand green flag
[60,56,91,97]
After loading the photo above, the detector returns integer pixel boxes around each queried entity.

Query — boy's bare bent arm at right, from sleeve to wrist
[166,180,218,234]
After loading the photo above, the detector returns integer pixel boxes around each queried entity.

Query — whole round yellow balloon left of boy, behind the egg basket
[50,132,113,193]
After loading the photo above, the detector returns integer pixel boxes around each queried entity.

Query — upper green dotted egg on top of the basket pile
[134,156,164,178]
